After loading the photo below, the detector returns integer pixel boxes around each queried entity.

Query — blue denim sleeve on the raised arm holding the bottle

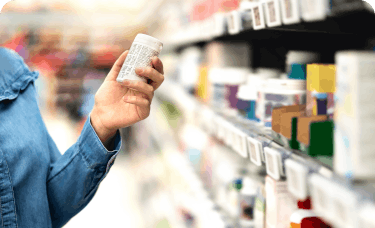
[47,118,121,227]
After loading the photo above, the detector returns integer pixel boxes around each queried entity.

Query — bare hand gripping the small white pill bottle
[90,51,164,142]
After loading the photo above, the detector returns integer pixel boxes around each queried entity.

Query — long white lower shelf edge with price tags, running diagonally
[156,81,375,227]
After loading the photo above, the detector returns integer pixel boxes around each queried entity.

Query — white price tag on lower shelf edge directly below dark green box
[309,174,334,222]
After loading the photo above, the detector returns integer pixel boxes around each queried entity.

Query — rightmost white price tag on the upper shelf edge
[301,0,329,21]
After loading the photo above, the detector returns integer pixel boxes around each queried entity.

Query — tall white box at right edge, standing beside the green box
[334,51,375,179]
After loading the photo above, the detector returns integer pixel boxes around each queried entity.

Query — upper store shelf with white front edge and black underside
[164,0,375,52]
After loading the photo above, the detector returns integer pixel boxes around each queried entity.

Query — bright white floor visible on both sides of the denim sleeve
[43,109,143,228]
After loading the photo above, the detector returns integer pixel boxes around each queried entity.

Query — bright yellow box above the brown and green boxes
[306,64,336,93]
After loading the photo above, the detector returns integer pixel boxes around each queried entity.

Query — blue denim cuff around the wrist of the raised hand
[79,116,122,172]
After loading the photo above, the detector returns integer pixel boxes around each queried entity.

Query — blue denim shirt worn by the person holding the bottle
[0,47,121,228]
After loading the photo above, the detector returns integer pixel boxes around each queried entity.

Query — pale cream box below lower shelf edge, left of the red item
[265,176,297,228]
